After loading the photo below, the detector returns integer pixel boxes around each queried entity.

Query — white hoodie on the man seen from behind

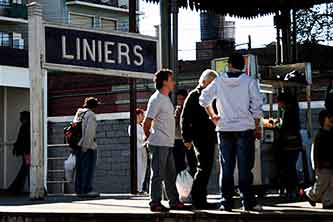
[199,73,263,132]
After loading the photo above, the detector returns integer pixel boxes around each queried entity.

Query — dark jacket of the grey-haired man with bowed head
[180,87,216,144]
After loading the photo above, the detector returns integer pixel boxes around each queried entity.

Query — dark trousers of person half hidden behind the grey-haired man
[173,140,197,177]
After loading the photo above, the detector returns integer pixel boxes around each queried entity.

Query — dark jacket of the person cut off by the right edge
[314,129,333,169]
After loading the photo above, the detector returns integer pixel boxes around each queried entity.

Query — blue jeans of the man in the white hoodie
[218,130,255,208]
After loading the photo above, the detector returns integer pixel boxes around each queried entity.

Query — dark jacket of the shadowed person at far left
[13,122,30,156]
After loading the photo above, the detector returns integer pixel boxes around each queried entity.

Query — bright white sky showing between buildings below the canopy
[140,1,276,60]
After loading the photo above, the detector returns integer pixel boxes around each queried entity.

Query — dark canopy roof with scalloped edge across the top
[145,0,333,18]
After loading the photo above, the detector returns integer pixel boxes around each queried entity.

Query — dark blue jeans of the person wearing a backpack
[75,149,97,194]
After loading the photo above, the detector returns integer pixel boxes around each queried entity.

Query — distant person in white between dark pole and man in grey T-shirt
[128,109,147,194]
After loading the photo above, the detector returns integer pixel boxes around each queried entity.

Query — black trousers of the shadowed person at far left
[8,156,30,194]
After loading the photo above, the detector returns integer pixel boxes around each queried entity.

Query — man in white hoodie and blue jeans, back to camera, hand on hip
[199,53,263,211]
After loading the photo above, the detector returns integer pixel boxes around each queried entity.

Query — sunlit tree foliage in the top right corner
[296,3,333,44]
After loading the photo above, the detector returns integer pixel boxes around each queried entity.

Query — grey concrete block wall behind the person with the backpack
[48,120,130,193]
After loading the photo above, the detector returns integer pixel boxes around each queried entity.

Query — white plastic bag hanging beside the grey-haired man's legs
[176,170,193,200]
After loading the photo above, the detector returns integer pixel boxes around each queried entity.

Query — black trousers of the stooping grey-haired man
[192,141,215,206]
